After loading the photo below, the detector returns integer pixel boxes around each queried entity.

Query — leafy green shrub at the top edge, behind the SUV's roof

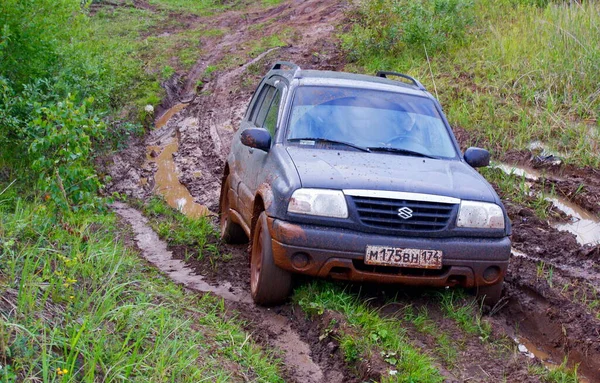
[342,0,473,60]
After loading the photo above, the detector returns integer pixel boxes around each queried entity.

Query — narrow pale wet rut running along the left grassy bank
[112,202,328,383]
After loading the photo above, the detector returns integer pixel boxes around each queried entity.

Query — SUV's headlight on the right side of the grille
[456,201,504,229]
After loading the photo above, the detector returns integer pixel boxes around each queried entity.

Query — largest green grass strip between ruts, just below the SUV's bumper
[293,281,443,382]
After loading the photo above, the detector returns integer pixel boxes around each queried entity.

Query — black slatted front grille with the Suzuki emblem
[351,196,457,231]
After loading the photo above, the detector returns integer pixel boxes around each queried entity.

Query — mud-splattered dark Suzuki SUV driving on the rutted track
[220,62,511,305]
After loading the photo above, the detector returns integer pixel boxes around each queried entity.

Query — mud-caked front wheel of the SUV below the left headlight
[250,212,292,306]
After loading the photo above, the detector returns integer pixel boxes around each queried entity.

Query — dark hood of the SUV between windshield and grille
[287,146,498,202]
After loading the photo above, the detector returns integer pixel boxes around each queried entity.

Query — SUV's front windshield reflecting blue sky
[287,86,456,158]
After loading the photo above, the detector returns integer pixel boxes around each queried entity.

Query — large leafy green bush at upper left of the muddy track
[0,0,145,209]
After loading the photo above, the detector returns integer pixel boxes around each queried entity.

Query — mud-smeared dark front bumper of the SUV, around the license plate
[268,218,511,287]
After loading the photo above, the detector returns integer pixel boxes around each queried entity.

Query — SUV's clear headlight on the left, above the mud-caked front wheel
[288,189,348,218]
